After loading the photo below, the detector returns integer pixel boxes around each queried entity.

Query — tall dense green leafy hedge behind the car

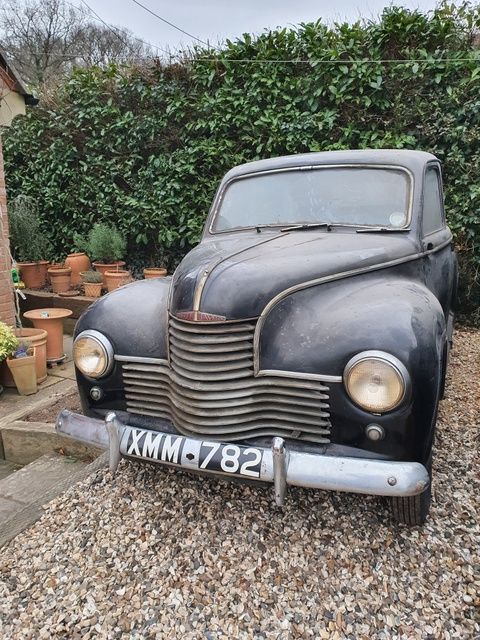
[4,5,480,318]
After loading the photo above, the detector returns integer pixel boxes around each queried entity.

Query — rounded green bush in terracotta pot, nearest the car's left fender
[86,223,127,282]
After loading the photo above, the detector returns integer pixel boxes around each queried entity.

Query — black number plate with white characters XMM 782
[121,427,263,478]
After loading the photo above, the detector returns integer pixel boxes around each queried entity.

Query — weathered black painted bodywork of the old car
[76,151,457,461]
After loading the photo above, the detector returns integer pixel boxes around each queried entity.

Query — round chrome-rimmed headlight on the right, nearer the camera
[343,351,409,413]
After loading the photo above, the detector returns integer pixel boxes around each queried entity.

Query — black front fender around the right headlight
[256,274,446,461]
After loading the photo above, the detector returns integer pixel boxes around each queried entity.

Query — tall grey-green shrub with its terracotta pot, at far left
[8,195,49,289]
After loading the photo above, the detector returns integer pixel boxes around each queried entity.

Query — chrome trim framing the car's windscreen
[208,163,415,236]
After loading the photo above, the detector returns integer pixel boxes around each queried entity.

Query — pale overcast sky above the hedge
[78,0,436,50]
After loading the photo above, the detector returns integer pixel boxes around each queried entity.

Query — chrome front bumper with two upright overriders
[56,410,430,505]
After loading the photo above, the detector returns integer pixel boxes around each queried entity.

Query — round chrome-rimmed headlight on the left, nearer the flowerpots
[73,330,113,378]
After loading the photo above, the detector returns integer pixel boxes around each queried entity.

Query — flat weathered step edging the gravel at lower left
[0,453,108,547]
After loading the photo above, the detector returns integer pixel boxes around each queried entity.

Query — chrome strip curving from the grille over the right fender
[253,234,453,375]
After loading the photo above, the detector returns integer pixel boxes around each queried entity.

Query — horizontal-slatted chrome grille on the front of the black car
[122,318,330,443]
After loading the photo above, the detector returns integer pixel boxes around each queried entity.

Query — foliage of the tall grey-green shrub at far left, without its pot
[8,194,50,262]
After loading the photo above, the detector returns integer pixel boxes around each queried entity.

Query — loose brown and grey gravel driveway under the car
[0,330,480,640]
